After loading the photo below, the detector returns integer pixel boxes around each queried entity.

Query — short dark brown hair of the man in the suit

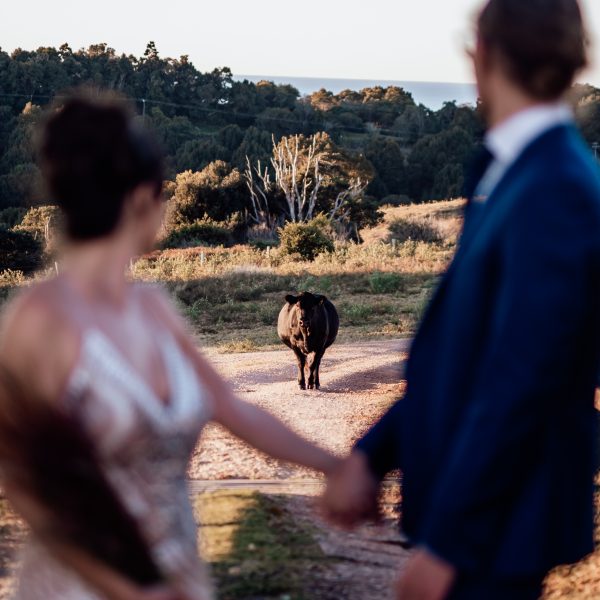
[478,0,588,100]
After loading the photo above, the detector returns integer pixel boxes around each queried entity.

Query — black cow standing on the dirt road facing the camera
[277,292,340,390]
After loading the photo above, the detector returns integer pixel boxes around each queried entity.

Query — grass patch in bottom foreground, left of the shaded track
[196,492,327,600]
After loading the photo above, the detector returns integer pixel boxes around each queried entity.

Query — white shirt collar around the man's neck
[485,102,573,165]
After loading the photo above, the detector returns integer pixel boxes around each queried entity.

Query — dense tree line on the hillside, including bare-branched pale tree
[0,42,600,239]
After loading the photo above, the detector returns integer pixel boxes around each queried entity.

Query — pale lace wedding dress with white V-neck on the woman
[16,288,213,600]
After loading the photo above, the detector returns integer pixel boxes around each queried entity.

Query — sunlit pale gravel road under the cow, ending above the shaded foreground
[189,340,409,480]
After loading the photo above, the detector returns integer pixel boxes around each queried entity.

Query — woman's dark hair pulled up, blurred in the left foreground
[40,93,163,240]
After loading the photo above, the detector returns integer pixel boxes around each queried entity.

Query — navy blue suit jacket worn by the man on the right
[357,125,600,577]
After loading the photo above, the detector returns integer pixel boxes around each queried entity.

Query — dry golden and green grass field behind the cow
[0,201,462,352]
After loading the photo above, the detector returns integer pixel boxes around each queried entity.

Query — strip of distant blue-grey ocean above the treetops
[235,75,477,110]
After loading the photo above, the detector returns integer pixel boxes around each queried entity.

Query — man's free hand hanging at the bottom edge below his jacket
[396,550,456,600]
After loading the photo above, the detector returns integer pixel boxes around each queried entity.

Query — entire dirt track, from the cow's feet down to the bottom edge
[189,340,409,600]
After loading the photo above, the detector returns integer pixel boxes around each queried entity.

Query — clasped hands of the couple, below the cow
[321,450,379,529]
